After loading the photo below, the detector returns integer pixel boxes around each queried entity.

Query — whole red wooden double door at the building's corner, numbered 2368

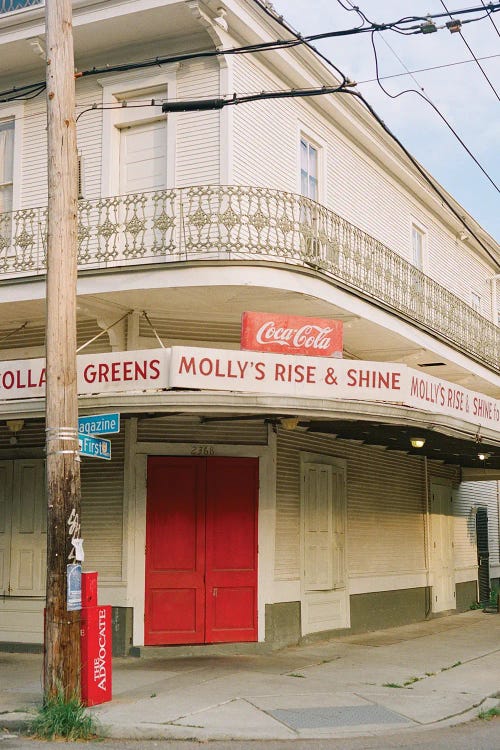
[144,456,258,646]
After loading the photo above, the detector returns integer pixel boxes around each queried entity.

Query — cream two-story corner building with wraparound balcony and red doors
[0,0,500,653]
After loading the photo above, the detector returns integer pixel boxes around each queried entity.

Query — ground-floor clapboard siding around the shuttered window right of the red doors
[275,432,425,580]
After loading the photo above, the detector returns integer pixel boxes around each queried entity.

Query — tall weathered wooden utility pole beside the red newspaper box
[44,0,80,699]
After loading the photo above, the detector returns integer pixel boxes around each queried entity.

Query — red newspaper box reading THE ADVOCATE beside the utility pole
[80,573,112,706]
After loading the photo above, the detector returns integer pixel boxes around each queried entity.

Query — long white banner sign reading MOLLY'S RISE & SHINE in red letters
[0,346,500,431]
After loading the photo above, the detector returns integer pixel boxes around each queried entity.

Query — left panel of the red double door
[144,456,205,645]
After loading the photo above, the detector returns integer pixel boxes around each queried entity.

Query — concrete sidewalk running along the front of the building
[0,611,500,740]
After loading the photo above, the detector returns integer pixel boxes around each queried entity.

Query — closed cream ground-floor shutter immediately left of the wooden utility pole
[10,458,47,596]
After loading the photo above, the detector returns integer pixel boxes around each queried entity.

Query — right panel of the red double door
[205,458,258,643]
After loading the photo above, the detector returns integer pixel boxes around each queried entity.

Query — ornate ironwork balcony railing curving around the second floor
[0,185,500,370]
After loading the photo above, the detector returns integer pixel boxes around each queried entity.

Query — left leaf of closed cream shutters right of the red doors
[303,464,333,591]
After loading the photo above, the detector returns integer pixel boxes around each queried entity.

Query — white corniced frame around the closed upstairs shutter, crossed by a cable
[98,65,178,198]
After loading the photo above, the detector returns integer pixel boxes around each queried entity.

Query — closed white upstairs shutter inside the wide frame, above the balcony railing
[120,120,167,193]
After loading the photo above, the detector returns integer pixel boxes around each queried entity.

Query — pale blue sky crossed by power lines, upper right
[273,0,500,242]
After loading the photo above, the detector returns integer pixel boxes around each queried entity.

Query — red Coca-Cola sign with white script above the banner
[241,312,342,357]
